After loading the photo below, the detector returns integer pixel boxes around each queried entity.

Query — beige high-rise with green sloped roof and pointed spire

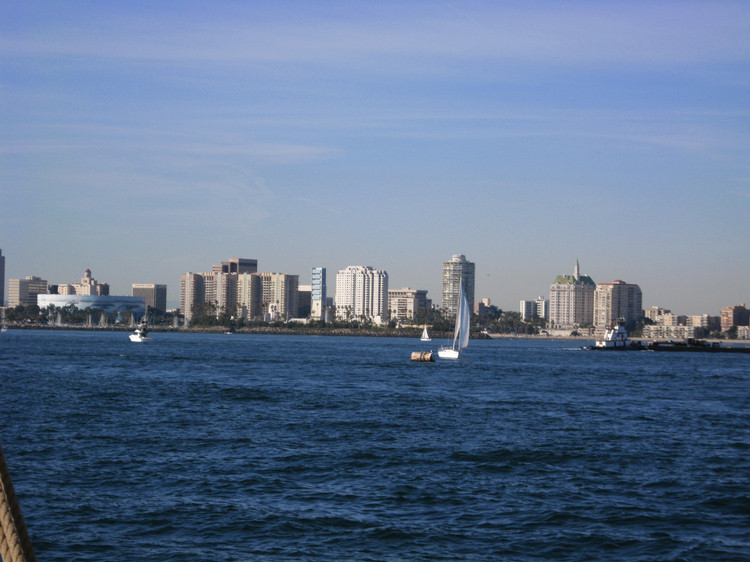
[549,260,596,328]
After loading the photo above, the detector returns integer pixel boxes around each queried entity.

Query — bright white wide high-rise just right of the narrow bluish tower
[334,265,388,324]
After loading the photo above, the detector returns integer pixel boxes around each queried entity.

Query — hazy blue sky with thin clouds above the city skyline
[0,0,750,314]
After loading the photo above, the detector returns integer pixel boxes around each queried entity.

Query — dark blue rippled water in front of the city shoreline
[0,330,750,562]
